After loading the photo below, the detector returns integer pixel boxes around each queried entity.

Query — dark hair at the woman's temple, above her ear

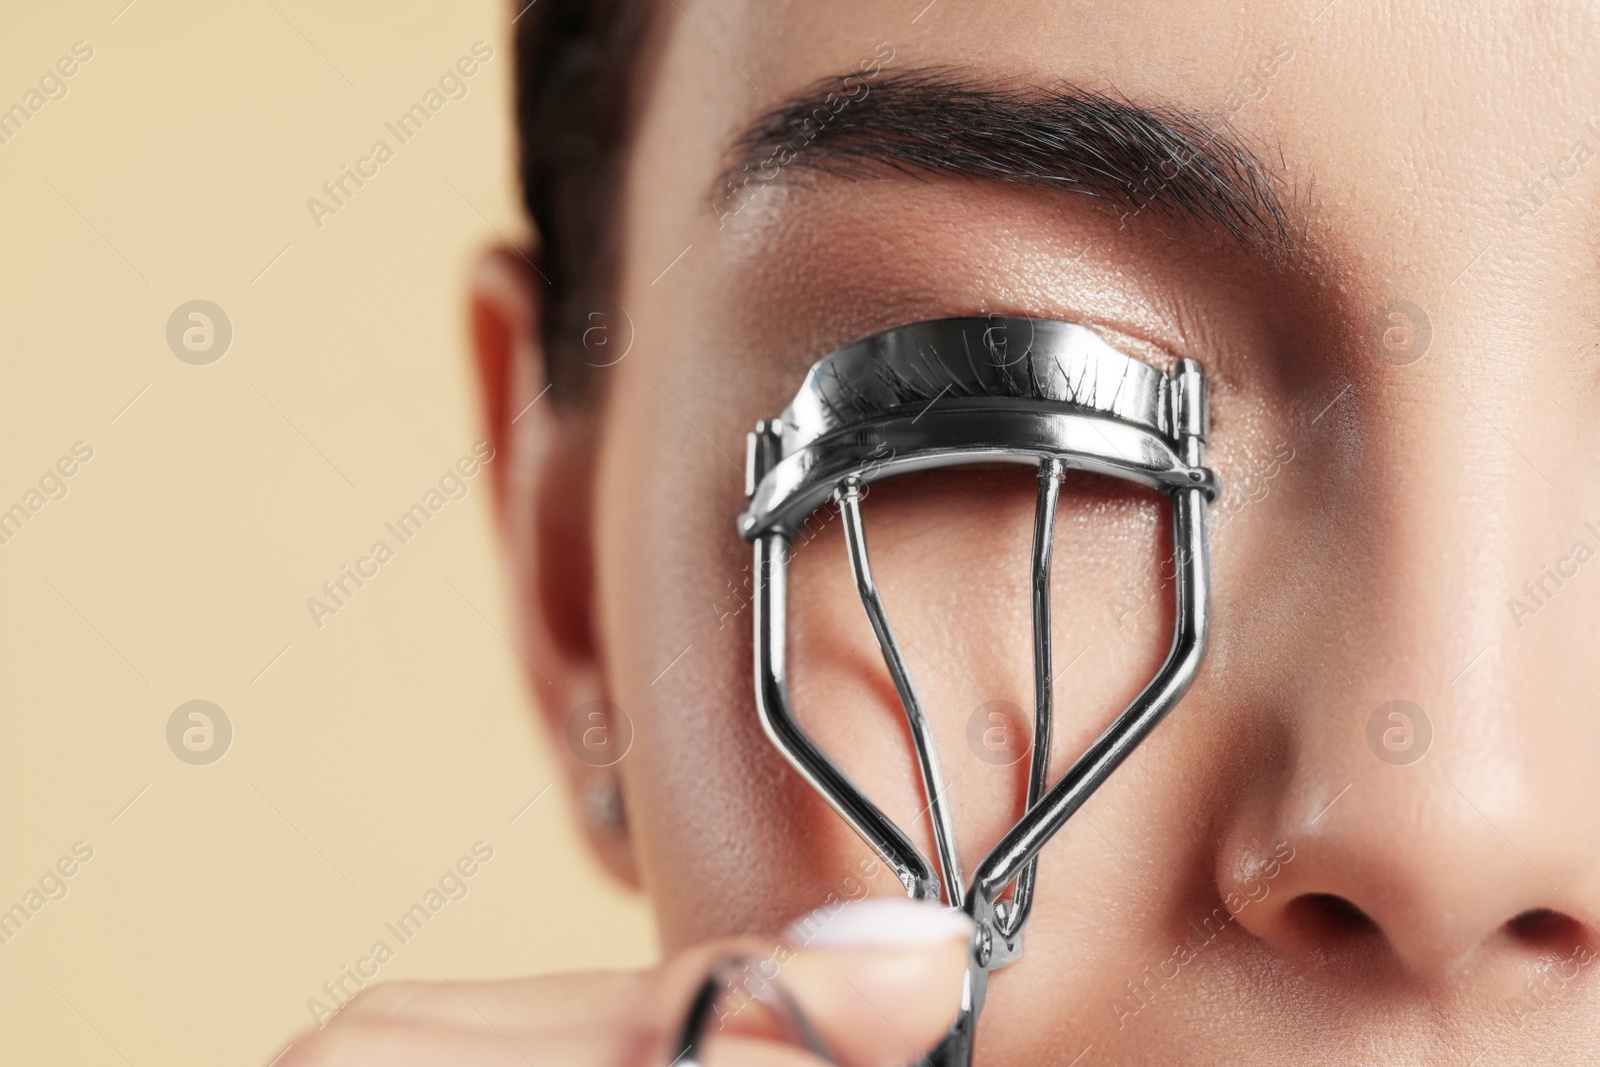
[514,0,648,405]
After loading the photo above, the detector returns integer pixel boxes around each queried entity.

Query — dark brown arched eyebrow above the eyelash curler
[714,67,1293,250]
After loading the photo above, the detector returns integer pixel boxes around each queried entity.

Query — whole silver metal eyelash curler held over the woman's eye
[677,317,1219,1067]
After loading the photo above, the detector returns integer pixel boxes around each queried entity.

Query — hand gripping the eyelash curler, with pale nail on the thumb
[278,897,971,1067]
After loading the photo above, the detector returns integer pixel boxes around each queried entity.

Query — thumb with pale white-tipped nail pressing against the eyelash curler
[768,897,973,1067]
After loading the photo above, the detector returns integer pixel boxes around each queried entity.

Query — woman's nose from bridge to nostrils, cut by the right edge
[1214,363,1600,981]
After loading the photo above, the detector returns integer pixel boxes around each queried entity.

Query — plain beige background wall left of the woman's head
[0,0,653,1067]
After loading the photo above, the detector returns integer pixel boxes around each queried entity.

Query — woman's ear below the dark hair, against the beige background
[470,246,640,888]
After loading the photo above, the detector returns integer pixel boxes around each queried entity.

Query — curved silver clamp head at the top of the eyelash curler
[738,318,1218,541]
